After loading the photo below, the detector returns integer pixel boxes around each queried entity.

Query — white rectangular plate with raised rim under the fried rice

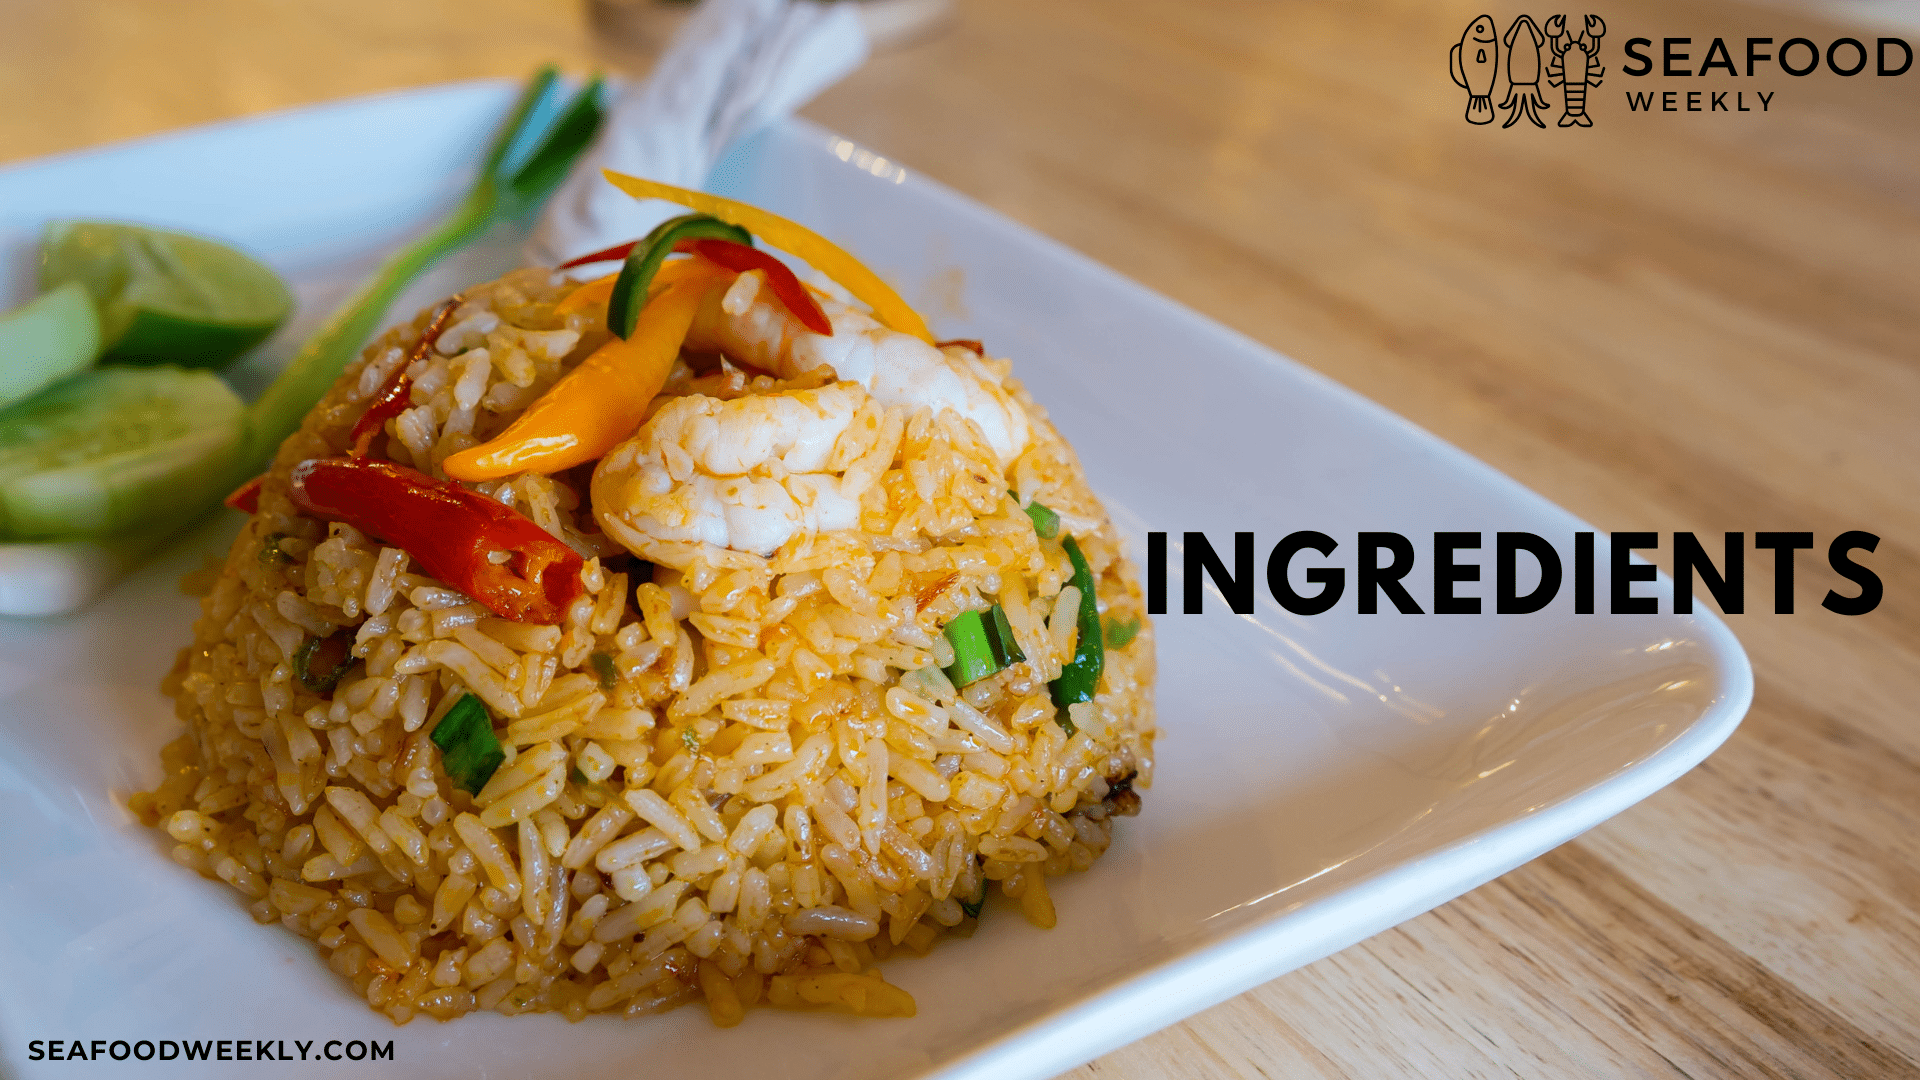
[0,83,1753,1080]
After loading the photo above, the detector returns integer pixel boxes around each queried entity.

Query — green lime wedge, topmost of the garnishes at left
[40,221,294,367]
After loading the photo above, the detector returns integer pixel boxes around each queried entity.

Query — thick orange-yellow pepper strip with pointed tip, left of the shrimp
[442,259,733,480]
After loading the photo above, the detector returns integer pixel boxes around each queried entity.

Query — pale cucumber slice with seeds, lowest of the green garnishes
[0,367,244,540]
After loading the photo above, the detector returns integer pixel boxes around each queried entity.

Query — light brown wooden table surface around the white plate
[0,0,1920,1078]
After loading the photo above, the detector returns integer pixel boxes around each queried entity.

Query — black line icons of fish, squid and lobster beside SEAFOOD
[1448,15,1607,127]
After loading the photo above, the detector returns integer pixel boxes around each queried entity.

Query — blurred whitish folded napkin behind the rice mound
[526,0,868,267]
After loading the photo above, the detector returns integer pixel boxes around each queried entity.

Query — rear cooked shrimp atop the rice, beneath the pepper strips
[687,273,1031,467]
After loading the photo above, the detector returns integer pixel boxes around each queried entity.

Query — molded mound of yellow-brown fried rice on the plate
[132,269,1154,1026]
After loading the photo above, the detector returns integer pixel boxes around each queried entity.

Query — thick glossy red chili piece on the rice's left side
[292,457,584,625]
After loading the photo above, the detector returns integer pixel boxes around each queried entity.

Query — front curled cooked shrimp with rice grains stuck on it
[593,382,904,569]
